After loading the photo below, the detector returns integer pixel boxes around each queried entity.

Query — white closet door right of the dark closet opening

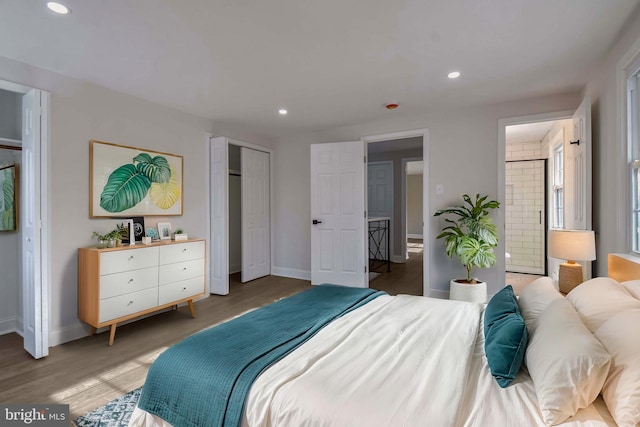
[240,147,271,283]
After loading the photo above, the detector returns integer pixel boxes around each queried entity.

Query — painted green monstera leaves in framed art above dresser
[100,153,175,212]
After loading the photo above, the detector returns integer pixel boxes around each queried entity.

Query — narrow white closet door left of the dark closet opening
[210,137,229,295]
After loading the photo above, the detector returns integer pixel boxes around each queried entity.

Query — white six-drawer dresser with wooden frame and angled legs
[78,239,205,345]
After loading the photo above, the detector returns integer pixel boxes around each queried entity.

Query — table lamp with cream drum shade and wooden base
[549,230,596,294]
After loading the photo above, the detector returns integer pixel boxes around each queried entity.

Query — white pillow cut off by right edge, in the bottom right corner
[595,310,640,427]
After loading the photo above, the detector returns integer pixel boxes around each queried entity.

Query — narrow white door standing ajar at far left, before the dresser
[20,90,49,359]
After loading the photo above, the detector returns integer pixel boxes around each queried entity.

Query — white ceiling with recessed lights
[0,0,639,139]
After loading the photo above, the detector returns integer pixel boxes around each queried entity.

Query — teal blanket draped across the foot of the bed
[138,285,384,427]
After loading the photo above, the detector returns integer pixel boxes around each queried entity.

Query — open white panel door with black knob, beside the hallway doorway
[311,141,369,288]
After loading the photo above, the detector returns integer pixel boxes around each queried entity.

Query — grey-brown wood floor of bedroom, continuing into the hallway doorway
[0,241,422,419]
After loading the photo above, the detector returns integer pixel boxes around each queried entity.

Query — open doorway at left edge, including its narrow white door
[0,81,50,359]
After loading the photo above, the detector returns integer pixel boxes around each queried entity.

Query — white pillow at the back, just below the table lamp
[567,277,640,332]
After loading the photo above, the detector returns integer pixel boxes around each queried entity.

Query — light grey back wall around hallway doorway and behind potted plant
[274,93,580,295]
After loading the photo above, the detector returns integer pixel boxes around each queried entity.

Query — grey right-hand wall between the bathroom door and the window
[585,5,640,276]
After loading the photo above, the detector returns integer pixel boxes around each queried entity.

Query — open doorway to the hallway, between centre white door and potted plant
[366,136,424,295]
